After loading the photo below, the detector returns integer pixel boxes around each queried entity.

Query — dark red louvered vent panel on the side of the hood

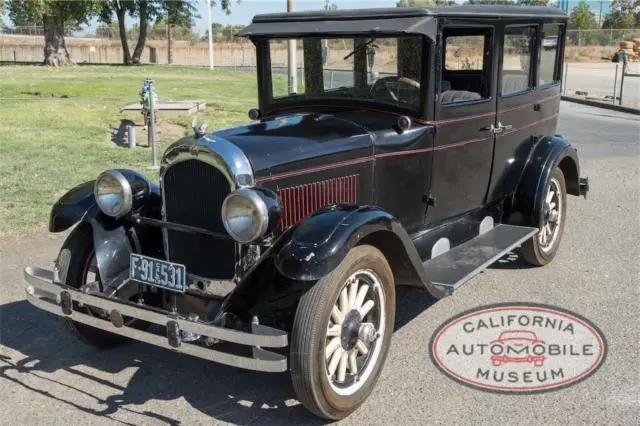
[279,175,358,228]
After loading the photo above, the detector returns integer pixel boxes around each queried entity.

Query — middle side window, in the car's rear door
[501,27,536,95]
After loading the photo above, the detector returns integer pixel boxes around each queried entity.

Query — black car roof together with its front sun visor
[237,5,567,39]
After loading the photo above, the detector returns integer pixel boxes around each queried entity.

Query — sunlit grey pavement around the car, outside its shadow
[0,103,640,425]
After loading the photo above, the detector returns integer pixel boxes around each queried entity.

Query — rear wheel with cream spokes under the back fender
[521,167,567,266]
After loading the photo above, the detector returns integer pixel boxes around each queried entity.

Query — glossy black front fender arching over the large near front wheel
[274,206,440,294]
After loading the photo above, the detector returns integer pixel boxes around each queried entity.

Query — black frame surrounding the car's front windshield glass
[254,33,431,118]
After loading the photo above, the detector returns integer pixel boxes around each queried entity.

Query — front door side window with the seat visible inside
[440,28,491,104]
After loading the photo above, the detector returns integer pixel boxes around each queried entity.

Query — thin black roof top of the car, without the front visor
[252,4,567,23]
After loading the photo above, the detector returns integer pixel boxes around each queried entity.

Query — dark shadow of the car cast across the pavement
[0,288,435,425]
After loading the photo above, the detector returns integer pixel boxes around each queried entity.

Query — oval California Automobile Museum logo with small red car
[429,303,607,394]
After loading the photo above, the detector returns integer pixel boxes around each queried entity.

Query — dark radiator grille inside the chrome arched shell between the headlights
[162,160,235,279]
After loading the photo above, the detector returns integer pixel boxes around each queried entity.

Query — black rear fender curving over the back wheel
[513,135,580,226]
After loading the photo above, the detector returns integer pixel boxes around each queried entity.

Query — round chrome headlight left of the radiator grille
[93,170,133,217]
